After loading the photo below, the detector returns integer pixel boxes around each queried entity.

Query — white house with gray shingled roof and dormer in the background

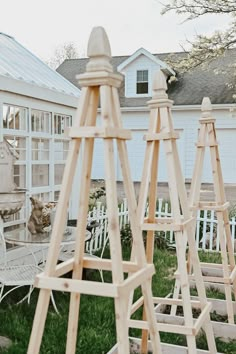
[57,48,236,199]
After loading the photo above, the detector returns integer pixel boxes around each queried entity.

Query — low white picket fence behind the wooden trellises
[86,199,236,253]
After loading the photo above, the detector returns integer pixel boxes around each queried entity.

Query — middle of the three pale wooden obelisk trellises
[138,71,216,354]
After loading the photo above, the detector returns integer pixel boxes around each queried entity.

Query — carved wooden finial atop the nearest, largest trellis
[86,27,113,72]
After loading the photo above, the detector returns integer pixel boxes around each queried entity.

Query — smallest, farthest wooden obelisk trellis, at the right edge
[189,97,236,324]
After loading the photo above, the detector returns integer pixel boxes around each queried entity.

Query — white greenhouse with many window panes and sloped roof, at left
[0,33,80,230]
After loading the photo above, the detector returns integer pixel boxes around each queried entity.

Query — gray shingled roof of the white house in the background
[57,49,236,107]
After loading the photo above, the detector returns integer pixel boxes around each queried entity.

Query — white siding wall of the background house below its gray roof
[92,107,236,183]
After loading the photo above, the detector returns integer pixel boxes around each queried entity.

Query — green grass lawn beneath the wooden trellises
[0,250,236,354]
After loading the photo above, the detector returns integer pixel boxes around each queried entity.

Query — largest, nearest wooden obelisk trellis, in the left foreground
[28,27,161,354]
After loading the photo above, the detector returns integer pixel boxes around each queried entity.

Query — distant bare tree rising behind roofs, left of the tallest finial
[47,42,79,69]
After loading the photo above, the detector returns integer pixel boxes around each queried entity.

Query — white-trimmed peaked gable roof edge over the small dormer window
[117,48,175,76]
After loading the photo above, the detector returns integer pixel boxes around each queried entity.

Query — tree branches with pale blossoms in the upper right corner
[162,0,236,72]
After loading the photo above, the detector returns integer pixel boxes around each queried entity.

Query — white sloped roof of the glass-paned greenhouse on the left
[0,33,80,105]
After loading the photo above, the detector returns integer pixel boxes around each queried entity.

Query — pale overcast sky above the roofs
[0,0,231,61]
